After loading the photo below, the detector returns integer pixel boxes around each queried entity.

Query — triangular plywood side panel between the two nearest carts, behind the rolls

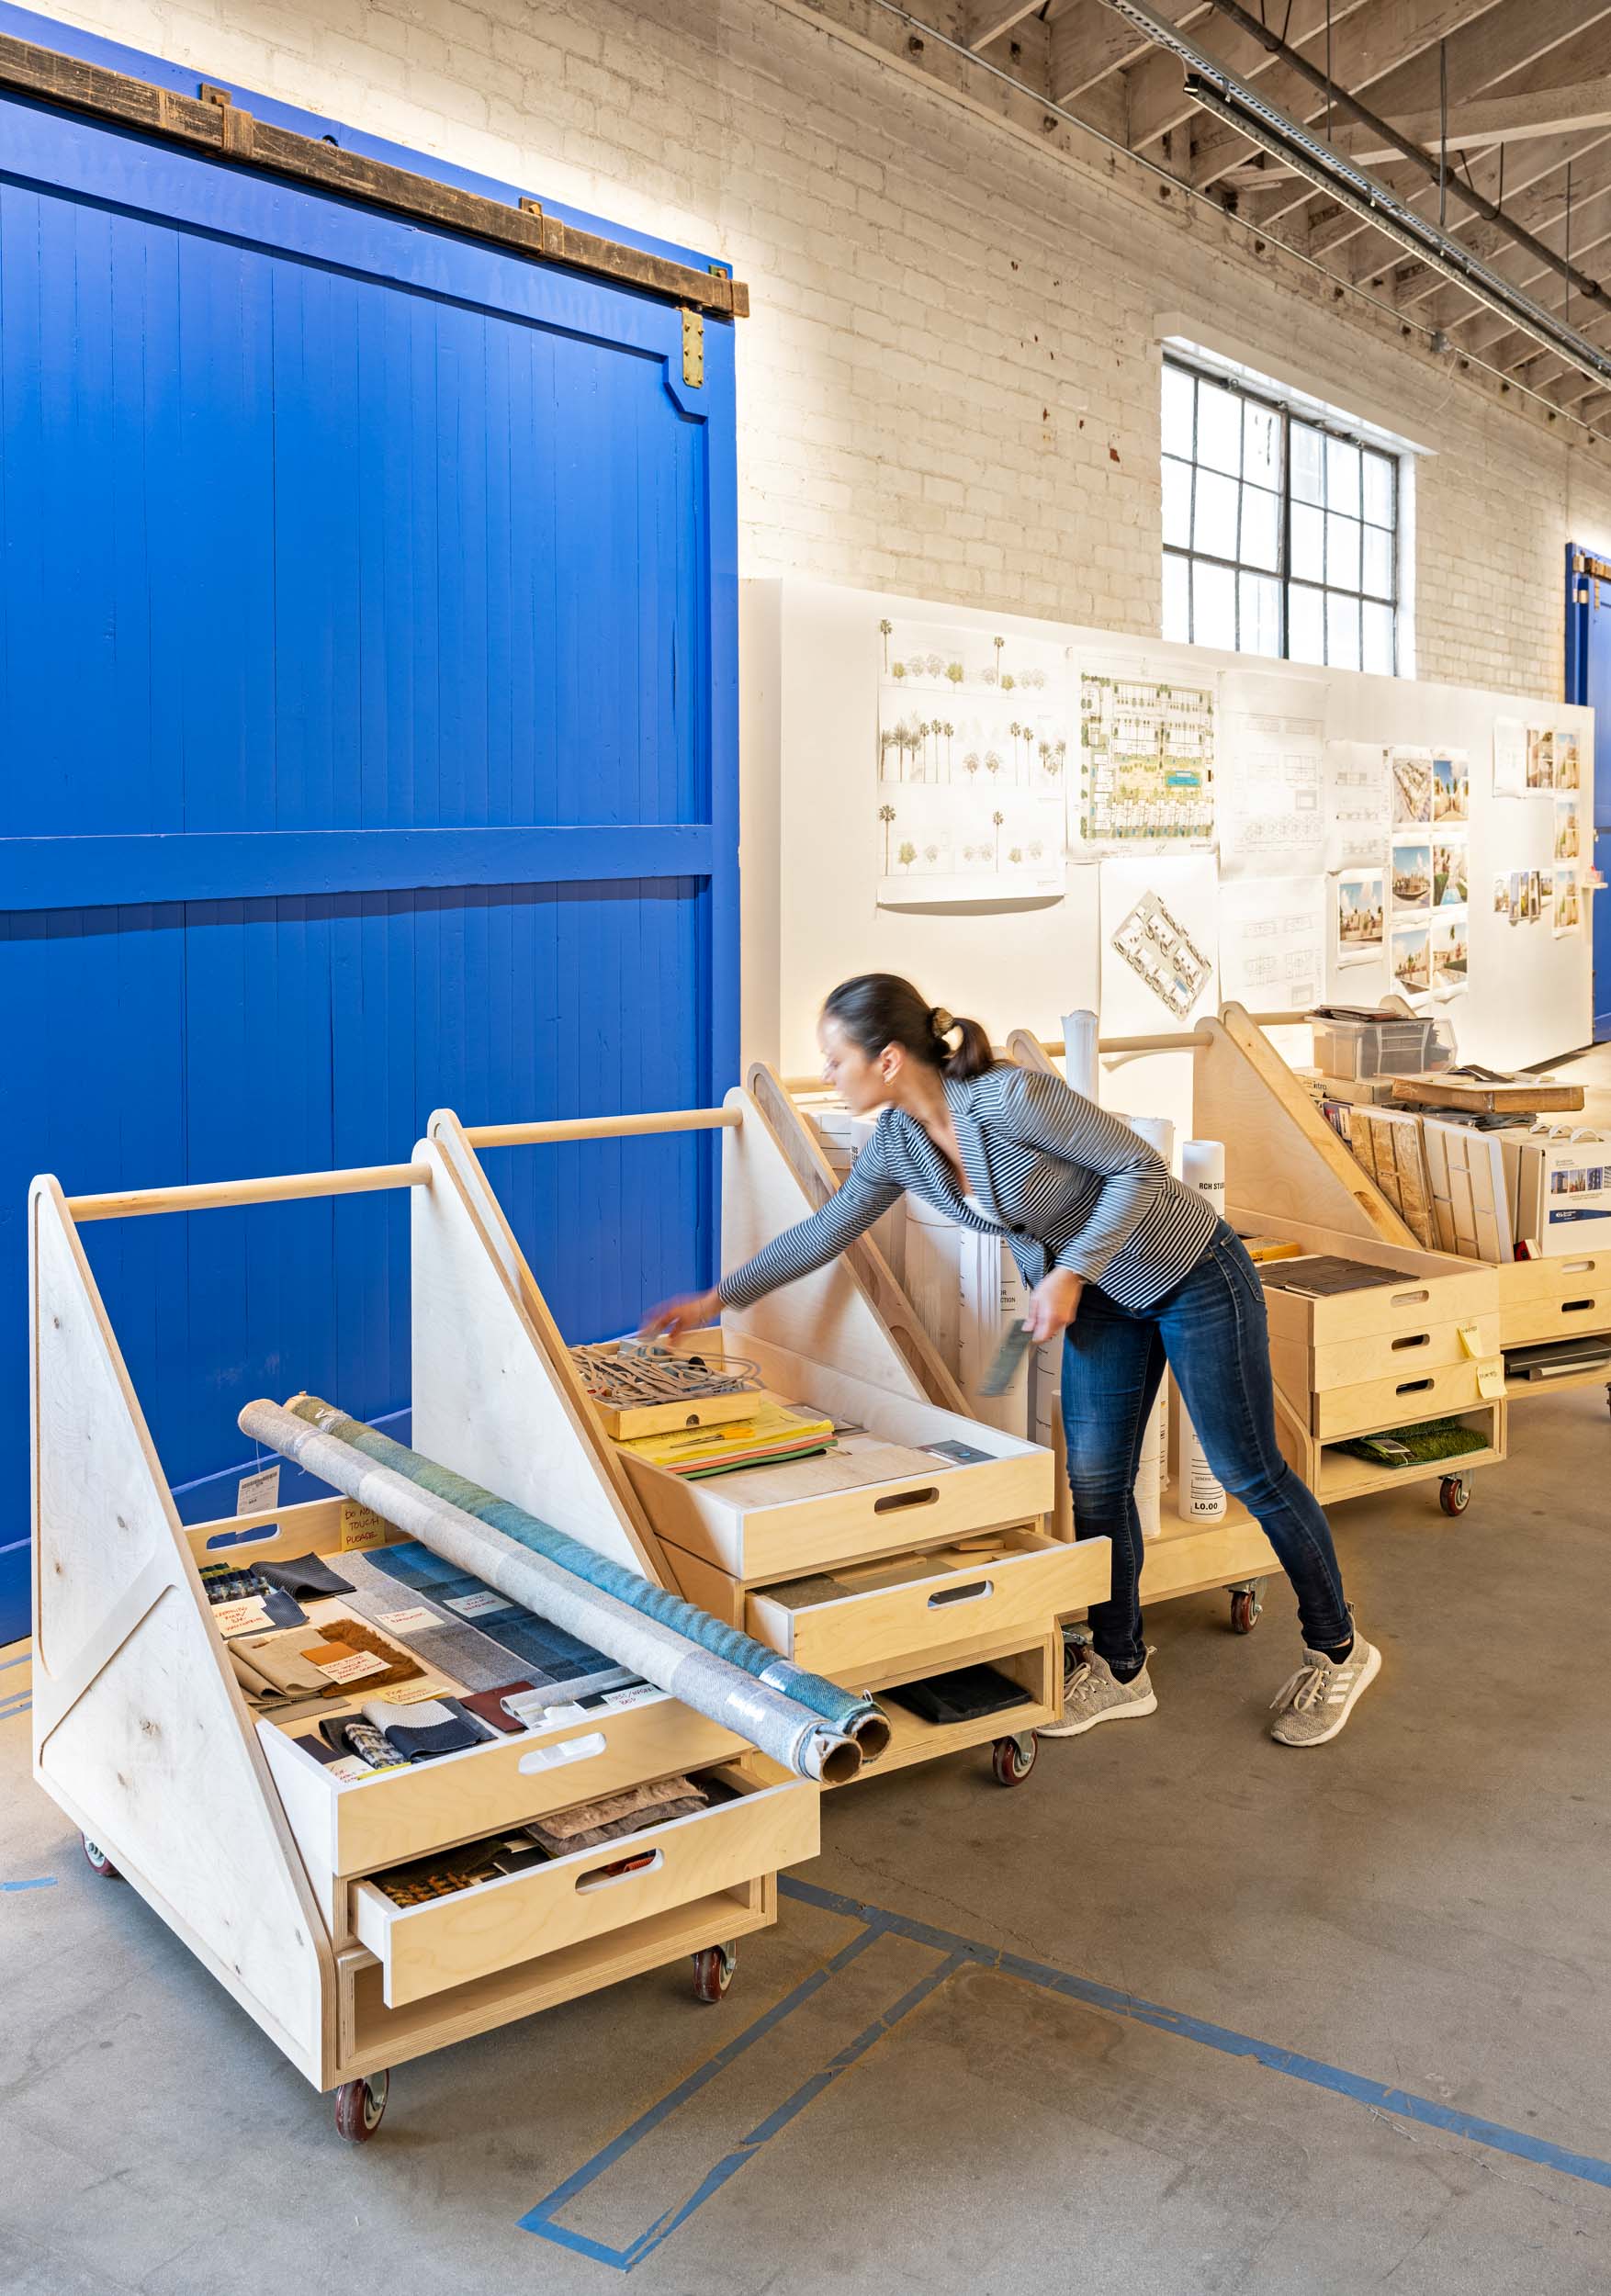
[411,1109,670,1587]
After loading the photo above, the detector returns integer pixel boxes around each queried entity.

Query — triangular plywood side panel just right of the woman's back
[1193,1006,1418,1252]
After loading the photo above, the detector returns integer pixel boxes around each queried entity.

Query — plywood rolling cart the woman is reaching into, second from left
[429,1075,1110,1784]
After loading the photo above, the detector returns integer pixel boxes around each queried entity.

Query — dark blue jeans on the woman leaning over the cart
[1063,1221,1354,1674]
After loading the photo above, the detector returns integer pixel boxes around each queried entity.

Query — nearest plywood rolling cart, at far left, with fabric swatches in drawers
[28,1142,819,2138]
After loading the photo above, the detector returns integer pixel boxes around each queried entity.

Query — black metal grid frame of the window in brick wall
[1159,349,1404,678]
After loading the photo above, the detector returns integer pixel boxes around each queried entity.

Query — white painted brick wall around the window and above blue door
[31,0,1611,696]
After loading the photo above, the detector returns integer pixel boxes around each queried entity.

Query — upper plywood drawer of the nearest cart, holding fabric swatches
[259,1697,749,1876]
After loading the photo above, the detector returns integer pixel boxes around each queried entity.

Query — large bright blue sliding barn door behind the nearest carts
[0,35,737,1642]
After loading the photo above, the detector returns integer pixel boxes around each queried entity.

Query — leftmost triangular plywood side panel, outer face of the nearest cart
[29,1180,335,2083]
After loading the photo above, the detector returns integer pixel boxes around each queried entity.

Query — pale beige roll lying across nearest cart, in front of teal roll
[239,1399,862,1786]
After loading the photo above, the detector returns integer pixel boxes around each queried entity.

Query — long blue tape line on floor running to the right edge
[778,1878,1611,2186]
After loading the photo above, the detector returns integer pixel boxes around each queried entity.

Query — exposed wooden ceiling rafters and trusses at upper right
[794,0,1611,434]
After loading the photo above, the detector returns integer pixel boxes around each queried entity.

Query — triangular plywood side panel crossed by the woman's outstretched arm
[721,1084,927,1410]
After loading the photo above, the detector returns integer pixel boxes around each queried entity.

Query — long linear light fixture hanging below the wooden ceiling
[1104,0,1611,388]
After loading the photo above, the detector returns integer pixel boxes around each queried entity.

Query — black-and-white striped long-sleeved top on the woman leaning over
[721,1064,1219,1313]
